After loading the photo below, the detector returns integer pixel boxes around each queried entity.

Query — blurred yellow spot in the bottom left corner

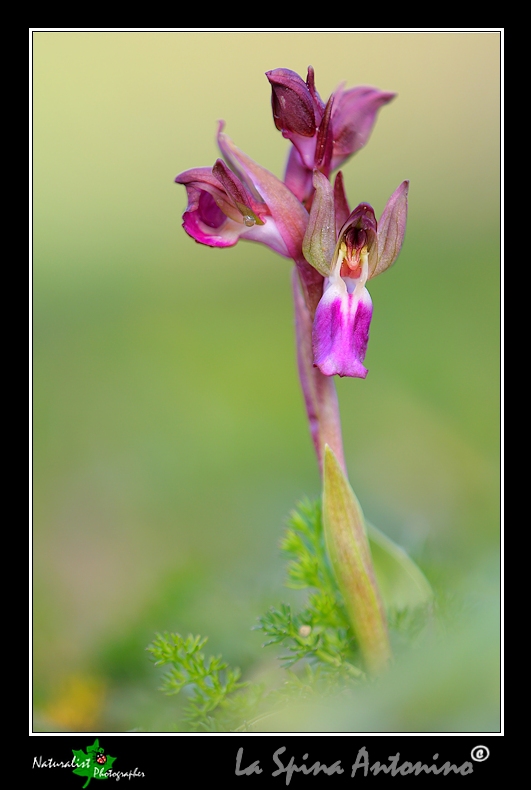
[44,675,105,732]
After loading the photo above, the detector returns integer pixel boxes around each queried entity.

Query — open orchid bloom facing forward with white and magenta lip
[303,171,409,378]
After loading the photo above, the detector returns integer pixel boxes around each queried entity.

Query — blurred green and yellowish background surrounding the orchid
[33,32,500,732]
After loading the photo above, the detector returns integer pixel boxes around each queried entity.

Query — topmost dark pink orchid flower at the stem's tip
[266,66,396,205]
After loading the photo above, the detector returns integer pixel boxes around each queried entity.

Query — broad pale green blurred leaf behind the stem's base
[365,521,433,609]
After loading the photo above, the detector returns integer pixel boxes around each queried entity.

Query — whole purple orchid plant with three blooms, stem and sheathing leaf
[175,67,408,674]
